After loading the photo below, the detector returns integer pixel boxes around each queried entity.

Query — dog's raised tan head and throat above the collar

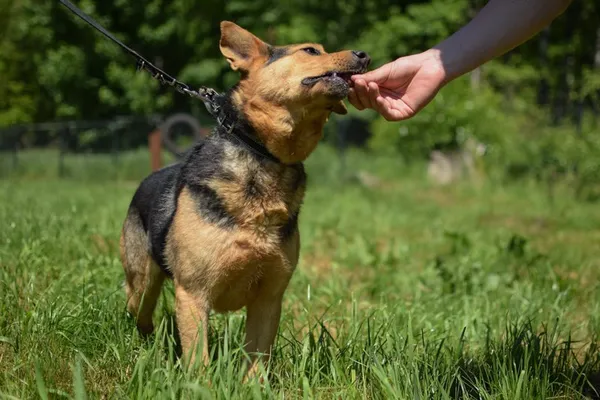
[219,21,370,163]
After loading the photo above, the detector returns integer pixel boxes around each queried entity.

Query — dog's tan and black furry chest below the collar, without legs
[167,159,305,311]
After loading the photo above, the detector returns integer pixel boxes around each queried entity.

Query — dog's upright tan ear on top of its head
[219,21,269,71]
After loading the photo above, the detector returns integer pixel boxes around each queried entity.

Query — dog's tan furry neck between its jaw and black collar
[222,88,330,164]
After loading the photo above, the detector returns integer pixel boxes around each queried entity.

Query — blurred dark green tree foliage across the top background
[0,0,598,125]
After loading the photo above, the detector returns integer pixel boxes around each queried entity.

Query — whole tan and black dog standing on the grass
[121,22,369,374]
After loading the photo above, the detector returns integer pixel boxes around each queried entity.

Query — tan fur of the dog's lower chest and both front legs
[167,189,299,376]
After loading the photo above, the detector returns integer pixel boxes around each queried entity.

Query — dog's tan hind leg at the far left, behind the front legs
[120,209,166,334]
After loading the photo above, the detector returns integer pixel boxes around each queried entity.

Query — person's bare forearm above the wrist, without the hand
[430,0,571,82]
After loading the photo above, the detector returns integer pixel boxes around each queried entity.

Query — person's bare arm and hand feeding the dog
[348,0,572,121]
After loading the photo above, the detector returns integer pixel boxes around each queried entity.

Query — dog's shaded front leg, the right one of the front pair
[244,295,283,381]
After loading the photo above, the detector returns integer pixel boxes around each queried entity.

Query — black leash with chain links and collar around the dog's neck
[59,0,280,162]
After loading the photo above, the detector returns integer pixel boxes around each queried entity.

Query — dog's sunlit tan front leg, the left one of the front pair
[175,282,210,366]
